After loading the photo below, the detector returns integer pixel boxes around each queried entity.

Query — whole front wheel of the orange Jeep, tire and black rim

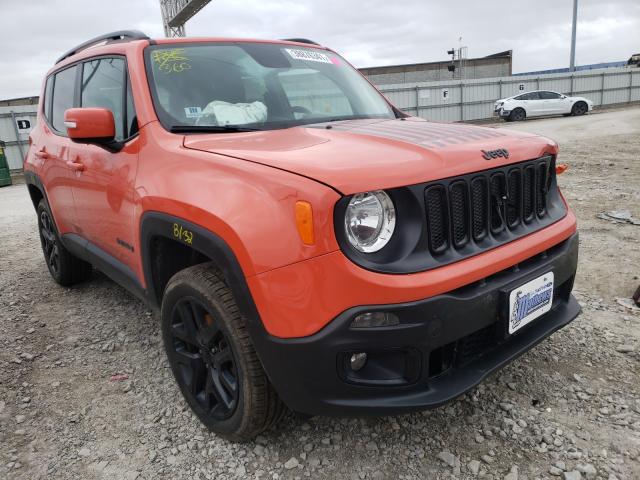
[161,263,285,441]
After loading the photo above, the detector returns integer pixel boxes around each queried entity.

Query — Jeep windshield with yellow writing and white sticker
[146,42,395,131]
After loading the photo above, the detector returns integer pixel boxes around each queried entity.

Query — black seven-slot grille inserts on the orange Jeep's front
[425,157,553,256]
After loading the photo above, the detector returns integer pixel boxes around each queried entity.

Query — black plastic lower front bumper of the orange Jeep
[257,233,580,416]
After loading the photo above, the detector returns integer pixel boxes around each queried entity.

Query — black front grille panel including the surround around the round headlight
[334,155,567,274]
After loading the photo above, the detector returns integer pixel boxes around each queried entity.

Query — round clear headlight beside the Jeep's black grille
[344,190,396,253]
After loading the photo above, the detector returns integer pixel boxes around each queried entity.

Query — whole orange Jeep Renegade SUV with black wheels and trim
[25,31,580,440]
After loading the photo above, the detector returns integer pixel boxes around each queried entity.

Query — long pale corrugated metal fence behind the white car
[378,68,640,122]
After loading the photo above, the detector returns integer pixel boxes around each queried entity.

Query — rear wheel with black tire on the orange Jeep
[37,198,91,287]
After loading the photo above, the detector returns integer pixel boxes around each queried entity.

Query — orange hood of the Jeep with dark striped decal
[184,118,557,194]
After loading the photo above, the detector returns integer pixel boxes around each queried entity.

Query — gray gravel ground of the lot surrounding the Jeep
[0,108,640,480]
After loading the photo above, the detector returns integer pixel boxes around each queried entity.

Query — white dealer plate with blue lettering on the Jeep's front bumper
[509,272,553,334]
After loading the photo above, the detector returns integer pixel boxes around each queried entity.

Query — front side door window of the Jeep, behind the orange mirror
[81,58,125,140]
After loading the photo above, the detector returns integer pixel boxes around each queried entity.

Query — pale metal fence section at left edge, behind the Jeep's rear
[0,97,38,171]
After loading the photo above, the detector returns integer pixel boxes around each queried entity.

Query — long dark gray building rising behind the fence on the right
[359,50,512,85]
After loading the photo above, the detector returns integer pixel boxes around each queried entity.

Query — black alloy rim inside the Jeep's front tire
[170,297,240,420]
